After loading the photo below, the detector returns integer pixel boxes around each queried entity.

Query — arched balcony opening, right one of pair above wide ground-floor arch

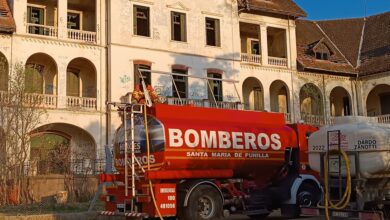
[66,58,97,108]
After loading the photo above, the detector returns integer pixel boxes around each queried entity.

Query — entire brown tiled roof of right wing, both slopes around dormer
[296,12,390,76]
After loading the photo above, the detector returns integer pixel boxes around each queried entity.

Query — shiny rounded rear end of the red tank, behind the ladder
[114,115,165,154]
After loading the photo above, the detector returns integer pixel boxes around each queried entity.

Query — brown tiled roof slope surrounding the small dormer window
[296,20,356,74]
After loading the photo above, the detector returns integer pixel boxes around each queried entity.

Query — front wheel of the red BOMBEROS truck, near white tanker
[282,182,322,218]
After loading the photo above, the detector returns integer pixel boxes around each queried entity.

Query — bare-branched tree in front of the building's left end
[0,61,46,205]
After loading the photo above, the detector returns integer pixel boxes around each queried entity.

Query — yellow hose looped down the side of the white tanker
[324,149,352,220]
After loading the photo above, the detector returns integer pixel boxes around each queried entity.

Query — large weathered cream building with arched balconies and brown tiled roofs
[0,0,390,172]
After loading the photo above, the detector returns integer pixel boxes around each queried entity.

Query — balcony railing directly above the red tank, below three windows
[167,98,242,110]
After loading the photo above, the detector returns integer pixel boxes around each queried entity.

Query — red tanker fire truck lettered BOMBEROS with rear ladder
[101,70,322,220]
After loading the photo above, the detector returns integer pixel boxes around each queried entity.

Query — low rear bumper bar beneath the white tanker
[301,207,385,220]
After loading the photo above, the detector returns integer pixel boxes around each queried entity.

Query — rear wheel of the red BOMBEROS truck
[178,185,223,220]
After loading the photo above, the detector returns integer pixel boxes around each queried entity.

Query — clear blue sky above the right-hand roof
[294,0,390,20]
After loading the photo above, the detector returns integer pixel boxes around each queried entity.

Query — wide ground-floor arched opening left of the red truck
[30,123,96,175]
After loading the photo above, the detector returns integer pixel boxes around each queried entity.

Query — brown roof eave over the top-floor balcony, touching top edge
[239,0,306,17]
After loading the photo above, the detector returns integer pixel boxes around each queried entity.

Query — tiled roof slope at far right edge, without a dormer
[358,12,390,75]
